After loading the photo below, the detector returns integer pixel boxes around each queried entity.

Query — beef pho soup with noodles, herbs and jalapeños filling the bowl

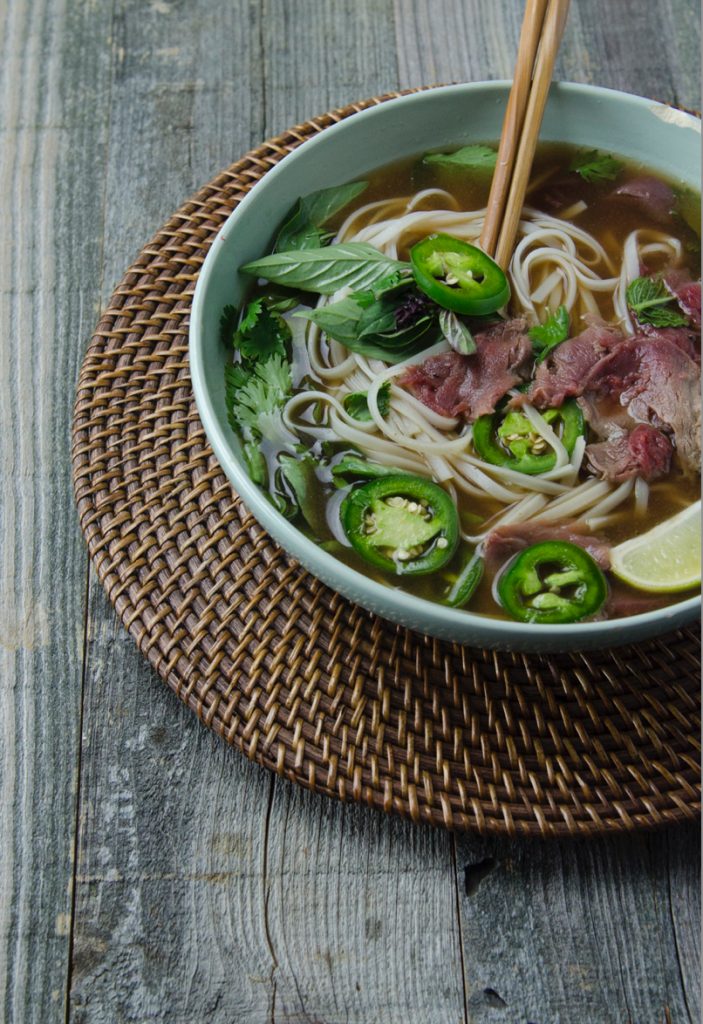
[222,143,701,624]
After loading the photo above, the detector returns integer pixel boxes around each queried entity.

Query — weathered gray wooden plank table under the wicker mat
[0,0,700,1024]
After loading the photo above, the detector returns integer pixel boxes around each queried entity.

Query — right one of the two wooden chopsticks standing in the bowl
[494,0,569,269]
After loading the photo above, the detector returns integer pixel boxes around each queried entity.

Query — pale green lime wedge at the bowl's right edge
[610,502,701,594]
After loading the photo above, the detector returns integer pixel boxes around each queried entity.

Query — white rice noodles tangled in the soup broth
[283,188,682,543]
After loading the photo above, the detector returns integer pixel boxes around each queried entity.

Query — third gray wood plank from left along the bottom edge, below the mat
[260,780,465,1024]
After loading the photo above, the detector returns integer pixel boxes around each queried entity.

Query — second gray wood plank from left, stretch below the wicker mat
[70,606,272,1024]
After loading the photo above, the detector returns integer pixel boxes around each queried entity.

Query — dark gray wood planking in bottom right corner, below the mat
[456,825,700,1024]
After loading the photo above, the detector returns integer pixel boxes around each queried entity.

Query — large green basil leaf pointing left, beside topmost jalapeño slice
[241,242,407,295]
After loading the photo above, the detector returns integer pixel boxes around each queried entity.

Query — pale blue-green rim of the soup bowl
[188,79,701,650]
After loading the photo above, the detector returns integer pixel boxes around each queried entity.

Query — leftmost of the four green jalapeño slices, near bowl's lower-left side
[341,473,459,575]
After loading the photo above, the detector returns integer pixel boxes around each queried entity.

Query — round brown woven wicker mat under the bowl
[74,97,699,837]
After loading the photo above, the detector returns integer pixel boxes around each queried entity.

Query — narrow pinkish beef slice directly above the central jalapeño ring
[511,322,624,409]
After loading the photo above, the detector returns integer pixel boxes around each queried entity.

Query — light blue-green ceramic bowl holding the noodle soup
[189,82,701,651]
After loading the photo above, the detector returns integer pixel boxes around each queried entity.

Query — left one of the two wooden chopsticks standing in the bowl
[479,0,547,256]
